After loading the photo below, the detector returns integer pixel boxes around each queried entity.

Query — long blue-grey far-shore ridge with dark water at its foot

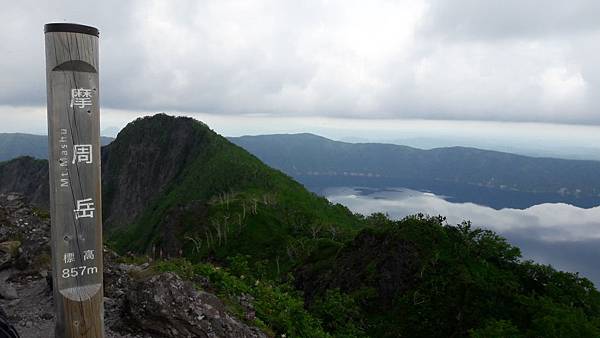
[230,134,600,208]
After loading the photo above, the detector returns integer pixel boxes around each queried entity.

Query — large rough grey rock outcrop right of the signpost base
[127,272,266,338]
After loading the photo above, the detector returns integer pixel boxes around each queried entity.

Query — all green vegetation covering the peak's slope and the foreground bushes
[104,116,600,338]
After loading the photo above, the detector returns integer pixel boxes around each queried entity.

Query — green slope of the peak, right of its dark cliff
[105,115,360,274]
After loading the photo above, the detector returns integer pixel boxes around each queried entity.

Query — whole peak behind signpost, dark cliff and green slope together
[0,114,360,271]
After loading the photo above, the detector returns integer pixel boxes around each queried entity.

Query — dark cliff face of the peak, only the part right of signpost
[102,114,217,231]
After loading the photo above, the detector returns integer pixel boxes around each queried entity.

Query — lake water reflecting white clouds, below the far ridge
[324,187,600,286]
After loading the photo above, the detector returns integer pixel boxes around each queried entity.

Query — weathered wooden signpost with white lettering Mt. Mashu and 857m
[44,23,104,338]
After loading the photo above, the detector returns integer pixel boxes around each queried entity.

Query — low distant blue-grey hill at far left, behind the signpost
[0,133,113,161]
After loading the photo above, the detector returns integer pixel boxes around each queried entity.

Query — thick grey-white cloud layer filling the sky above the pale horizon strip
[0,0,600,124]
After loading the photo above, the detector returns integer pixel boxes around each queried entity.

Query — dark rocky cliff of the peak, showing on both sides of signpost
[0,114,214,229]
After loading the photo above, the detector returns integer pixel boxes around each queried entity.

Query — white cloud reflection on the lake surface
[327,189,600,242]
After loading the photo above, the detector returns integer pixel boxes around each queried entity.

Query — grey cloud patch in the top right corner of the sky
[421,0,600,40]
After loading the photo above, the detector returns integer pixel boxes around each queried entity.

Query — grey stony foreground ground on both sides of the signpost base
[0,193,266,338]
